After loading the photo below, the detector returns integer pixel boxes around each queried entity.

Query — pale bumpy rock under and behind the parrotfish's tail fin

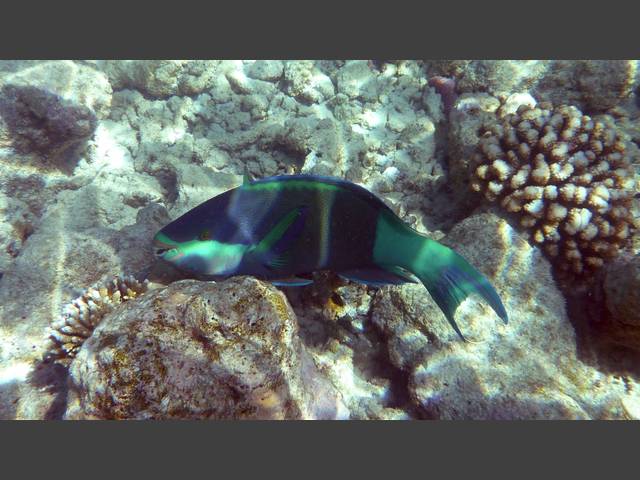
[372,214,640,419]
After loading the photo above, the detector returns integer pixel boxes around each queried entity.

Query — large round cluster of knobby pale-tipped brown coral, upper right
[471,103,640,277]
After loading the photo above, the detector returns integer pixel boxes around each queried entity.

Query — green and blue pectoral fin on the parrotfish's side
[248,206,309,269]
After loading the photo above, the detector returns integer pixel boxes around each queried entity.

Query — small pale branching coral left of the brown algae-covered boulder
[47,276,149,364]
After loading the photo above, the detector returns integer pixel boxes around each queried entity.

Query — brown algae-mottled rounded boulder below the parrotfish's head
[66,277,346,419]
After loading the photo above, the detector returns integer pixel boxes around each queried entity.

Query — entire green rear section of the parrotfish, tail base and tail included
[374,215,508,341]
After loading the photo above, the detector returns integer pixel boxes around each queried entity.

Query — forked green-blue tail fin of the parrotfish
[411,238,508,340]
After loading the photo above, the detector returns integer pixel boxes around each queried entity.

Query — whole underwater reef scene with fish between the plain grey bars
[0,60,640,420]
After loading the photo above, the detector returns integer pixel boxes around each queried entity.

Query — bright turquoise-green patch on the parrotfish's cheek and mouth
[154,233,249,275]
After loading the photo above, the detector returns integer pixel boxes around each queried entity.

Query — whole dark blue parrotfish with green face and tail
[154,175,508,340]
